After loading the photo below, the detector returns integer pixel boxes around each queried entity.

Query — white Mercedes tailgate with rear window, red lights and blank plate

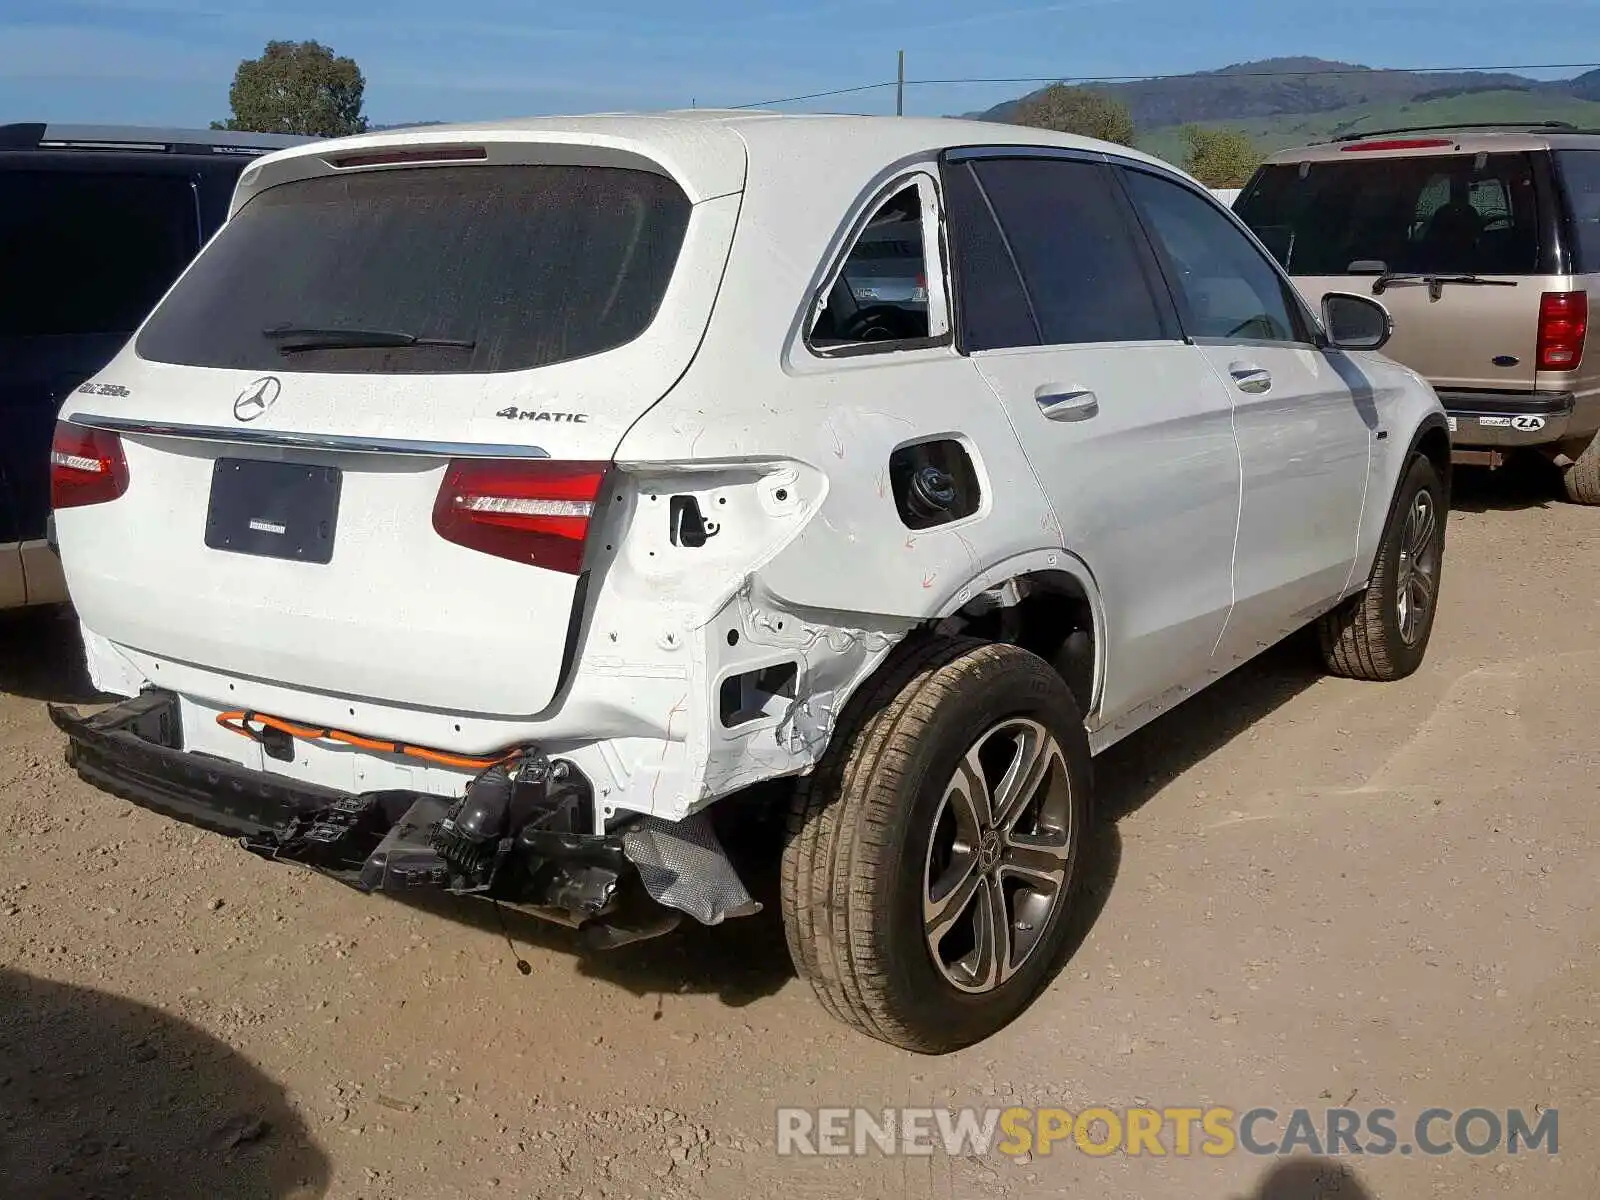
[56,147,738,715]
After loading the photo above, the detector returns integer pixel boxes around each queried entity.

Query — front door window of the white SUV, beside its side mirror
[1123,170,1310,342]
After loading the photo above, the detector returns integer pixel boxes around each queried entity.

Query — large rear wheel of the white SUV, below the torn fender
[782,638,1090,1054]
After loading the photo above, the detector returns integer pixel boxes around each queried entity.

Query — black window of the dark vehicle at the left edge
[0,170,200,338]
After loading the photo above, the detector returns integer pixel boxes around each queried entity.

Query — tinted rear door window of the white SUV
[962,158,1171,349]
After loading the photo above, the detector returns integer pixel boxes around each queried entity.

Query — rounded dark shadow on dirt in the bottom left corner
[0,970,328,1200]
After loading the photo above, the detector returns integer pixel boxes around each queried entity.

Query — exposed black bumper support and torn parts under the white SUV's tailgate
[50,690,760,946]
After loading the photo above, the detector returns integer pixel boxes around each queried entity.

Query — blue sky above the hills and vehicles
[0,0,1600,125]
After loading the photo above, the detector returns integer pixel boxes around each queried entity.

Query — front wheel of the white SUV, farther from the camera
[1317,454,1448,683]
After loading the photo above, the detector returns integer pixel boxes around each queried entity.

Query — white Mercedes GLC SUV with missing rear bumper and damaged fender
[53,112,1450,1053]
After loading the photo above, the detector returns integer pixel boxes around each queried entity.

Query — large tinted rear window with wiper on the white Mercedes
[138,166,690,374]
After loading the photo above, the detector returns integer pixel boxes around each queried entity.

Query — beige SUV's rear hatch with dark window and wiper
[1235,138,1558,392]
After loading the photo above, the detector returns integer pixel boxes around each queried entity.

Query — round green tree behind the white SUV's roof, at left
[211,42,366,138]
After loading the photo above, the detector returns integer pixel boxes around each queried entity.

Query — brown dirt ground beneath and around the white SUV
[0,464,1600,1200]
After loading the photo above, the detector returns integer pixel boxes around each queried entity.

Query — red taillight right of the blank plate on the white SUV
[434,459,611,574]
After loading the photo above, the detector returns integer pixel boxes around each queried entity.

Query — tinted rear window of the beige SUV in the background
[1235,154,1539,275]
